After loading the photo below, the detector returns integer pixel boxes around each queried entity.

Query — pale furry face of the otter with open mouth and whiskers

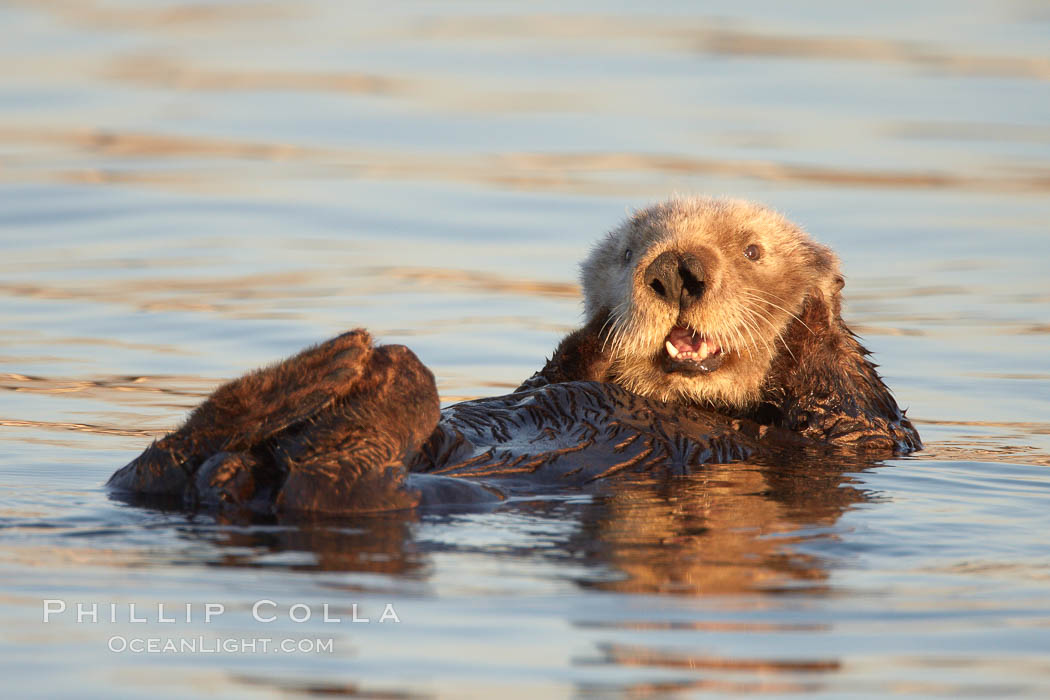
[582,198,842,408]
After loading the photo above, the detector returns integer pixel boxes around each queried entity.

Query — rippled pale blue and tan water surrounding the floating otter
[0,0,1050,698]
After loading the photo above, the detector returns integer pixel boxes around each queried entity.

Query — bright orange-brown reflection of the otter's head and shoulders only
[571,463,865,595]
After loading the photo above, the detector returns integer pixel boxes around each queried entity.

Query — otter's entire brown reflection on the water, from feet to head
[165,459,869,596]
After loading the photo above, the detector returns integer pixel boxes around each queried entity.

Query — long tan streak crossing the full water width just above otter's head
[0,123,1050,196]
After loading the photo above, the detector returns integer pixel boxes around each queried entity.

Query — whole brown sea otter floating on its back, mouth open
[109,197,921,514]
